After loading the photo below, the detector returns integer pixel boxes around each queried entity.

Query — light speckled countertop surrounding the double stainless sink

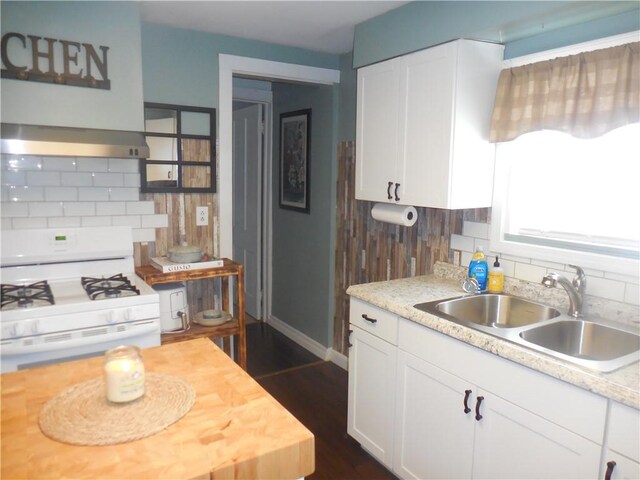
[347,275,640,409]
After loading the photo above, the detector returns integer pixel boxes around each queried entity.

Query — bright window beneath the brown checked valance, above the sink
[491,123,640,275]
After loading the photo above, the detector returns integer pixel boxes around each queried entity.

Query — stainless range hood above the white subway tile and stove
[0,123,149,158]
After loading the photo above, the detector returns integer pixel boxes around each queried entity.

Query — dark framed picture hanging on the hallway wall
[280,109,311,213]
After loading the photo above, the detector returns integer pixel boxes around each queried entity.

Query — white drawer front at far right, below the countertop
[608,401,640,462]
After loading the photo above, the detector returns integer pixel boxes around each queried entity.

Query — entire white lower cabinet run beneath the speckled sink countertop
[347,298,640,480]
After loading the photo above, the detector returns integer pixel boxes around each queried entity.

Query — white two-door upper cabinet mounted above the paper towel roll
[356,40,504,209]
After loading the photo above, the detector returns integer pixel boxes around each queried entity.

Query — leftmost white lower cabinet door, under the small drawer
[347,325,396,468]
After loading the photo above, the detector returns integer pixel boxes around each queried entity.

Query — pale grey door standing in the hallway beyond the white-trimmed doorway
[233,103,263,320]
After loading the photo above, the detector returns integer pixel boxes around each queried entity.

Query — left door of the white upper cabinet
[356,59,400,202]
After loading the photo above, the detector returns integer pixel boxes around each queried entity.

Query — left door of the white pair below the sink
[393,350,476,479]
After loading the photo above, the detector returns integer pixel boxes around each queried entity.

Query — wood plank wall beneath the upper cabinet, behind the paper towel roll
[333,142,489,355]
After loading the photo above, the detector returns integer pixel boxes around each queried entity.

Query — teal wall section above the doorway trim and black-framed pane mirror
[142,23,340,108]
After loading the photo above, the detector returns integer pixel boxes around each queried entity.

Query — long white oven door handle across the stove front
[0,320,160,357]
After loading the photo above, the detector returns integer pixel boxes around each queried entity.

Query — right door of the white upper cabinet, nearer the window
[398,42,457,208]
